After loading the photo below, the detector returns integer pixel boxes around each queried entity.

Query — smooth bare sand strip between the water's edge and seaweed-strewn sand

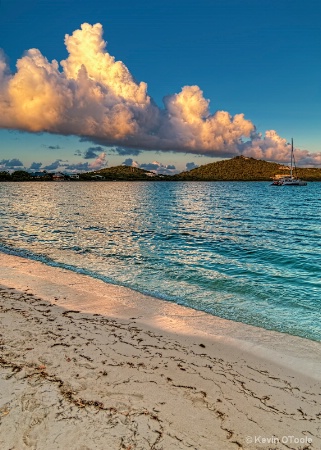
[0,252,321,380]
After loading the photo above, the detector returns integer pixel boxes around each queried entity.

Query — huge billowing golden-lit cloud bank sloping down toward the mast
[0,23,321,164]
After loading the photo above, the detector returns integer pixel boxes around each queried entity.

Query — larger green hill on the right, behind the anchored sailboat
[172,156,321,181]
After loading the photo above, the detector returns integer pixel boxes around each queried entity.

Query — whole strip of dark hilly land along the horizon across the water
[0,156,321,182]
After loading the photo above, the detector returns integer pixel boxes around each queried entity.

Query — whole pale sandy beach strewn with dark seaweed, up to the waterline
[0,254,321,450]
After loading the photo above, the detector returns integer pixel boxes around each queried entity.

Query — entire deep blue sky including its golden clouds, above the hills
[0,0,321,173]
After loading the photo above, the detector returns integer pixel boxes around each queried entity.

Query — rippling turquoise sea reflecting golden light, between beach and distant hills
[0,182,321,341]
